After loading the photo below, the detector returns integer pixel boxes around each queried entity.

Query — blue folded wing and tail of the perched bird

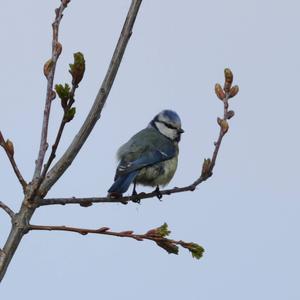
[108,147,176,194]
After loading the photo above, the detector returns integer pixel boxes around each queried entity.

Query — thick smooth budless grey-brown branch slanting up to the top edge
[41,0,142,194]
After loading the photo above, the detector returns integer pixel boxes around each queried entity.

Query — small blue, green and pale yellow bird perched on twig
[108,109,184,202]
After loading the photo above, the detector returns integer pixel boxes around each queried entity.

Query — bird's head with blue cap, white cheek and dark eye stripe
[149,109,184,142]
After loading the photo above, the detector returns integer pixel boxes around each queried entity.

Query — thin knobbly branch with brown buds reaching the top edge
[33,1,70,179]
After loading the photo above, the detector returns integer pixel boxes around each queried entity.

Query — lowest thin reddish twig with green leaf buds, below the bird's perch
[28,223,204,259]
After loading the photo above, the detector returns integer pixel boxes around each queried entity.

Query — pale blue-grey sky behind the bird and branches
[0,0,300,300]
